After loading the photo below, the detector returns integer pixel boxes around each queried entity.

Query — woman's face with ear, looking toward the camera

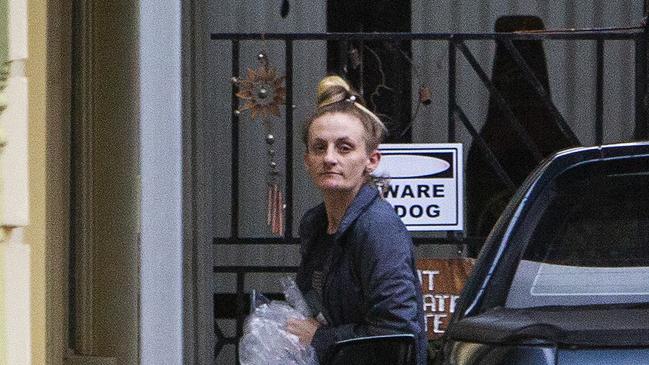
[304,113,381,194]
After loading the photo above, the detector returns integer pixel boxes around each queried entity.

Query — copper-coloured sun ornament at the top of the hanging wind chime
[233,52,286,120]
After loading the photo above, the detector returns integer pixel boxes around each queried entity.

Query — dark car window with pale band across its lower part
[506,159,649,308]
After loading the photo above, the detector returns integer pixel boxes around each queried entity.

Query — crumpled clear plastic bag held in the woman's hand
[239,278,318,365]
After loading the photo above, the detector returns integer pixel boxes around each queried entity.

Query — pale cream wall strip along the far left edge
[0,0,31,365]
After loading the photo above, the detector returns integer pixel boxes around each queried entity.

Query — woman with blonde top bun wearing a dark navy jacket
[287,76,427,365]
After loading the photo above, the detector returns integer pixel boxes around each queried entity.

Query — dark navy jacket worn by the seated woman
[297,186,427,365]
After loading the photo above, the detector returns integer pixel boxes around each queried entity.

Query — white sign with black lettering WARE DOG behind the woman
[373,143,464,231]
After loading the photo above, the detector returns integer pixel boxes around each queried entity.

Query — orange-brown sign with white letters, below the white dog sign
[416,258,474,340]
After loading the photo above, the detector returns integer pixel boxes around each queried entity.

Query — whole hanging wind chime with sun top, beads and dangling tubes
[232,51,286,236]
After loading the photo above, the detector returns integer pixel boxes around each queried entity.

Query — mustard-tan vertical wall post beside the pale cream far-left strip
[25,1,70,365]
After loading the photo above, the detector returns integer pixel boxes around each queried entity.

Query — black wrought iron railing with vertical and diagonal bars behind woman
[211,28,649,364]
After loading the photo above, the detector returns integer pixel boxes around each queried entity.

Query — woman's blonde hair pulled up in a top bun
[302,76,387,152]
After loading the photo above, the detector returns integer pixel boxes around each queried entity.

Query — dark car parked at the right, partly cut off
[436,142,649,365]
